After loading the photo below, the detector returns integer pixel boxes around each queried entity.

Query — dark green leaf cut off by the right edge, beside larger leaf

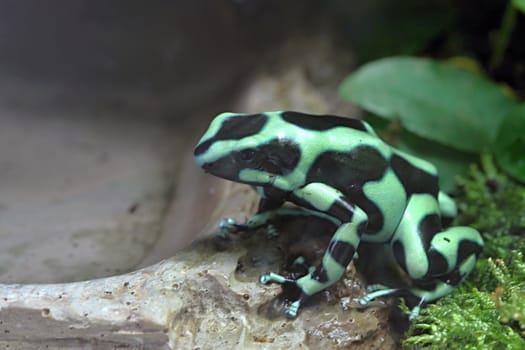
[494,103,525,182]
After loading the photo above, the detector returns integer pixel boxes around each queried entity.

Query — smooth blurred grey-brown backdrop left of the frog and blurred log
[0,0,334,283]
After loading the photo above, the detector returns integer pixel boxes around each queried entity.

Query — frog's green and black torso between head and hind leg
[283,116,439,240]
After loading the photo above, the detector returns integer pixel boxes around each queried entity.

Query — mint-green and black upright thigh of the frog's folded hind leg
[391,194,441,279]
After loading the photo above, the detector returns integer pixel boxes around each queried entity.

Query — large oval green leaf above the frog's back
[340,57,516,152]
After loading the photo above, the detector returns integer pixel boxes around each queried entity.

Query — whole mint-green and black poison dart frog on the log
[194,111,483,319]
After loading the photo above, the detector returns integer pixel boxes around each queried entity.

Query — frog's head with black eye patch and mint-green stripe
[194,113,300,185]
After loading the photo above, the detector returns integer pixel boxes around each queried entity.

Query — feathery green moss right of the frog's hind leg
[402,155,525,349]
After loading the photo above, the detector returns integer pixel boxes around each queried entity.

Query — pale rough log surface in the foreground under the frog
[0,216,394,349]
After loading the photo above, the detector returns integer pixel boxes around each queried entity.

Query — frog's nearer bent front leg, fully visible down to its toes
[260,183,368,318]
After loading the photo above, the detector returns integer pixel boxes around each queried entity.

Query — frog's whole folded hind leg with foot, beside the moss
[361,194,483,318]
